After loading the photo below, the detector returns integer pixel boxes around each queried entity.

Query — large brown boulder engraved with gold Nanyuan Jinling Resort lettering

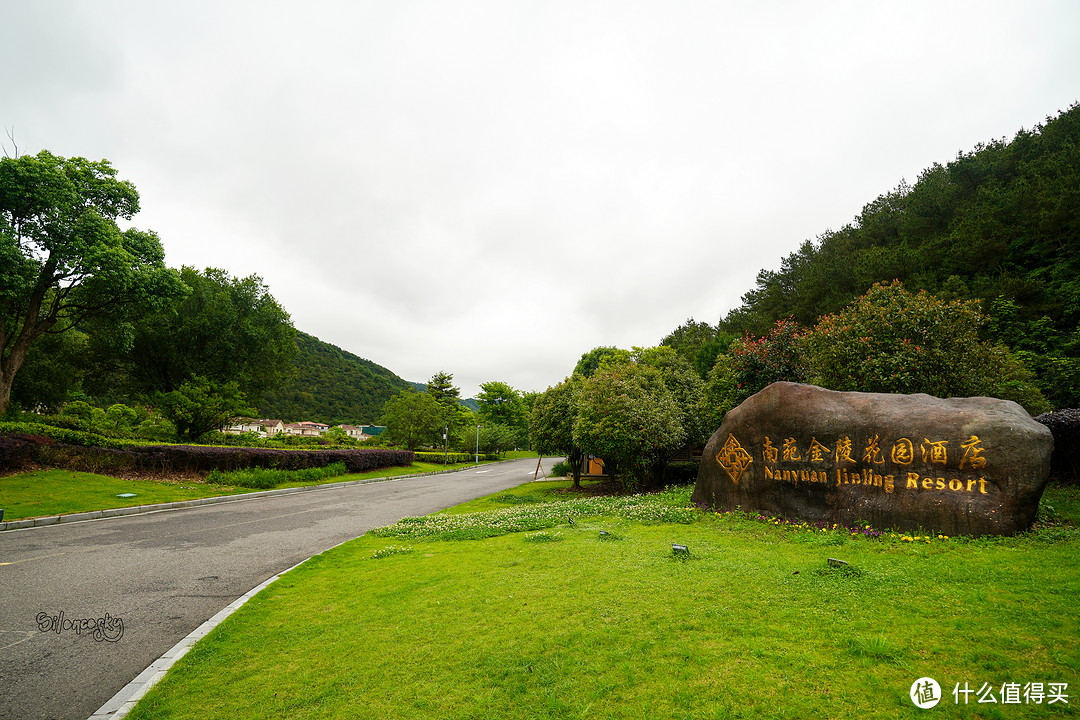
[693,382,1054,535]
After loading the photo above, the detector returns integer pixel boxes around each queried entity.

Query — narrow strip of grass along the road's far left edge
[0,462,494,521]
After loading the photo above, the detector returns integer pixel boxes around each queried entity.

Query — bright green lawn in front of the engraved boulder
[122,483,1080,720]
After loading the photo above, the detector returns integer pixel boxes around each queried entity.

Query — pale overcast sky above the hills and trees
[0,0,1080,399]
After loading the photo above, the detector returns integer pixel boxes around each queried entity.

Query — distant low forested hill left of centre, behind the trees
[258,331,409,425]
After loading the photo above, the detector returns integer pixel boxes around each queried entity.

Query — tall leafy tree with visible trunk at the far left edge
[0,150,183,413]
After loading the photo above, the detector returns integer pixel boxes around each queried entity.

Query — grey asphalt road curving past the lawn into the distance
[0,459,554,720]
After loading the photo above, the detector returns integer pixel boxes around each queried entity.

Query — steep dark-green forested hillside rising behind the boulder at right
[716,105,1080,407]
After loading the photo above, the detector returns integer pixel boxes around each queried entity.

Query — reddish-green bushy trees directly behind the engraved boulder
[705,282,1049,424]
